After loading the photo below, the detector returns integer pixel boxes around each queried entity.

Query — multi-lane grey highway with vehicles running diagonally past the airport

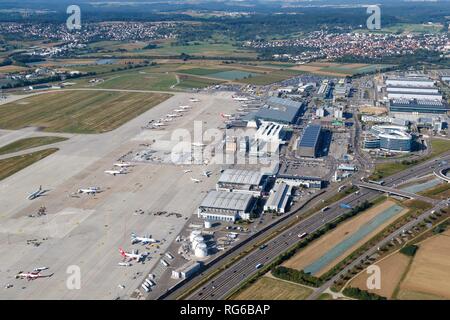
[181,154,450,300]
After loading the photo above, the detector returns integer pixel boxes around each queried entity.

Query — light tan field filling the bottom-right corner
[397,230,450,299]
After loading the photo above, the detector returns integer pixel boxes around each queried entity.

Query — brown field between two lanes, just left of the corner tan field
[348,252,411,299]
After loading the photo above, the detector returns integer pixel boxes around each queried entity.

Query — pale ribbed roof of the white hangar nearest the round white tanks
[200,190,253,211]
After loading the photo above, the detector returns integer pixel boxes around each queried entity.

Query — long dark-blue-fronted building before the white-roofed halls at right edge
[389,99,449,115]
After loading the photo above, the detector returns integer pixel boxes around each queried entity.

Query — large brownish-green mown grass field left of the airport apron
[0,91,170,133]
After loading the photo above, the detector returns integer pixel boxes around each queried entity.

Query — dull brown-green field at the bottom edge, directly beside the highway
[232,276,312,300]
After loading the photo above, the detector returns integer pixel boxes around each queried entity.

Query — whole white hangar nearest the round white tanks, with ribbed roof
[197,190,256,222]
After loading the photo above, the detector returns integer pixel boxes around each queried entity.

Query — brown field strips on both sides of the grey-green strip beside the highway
[283,200,408,276]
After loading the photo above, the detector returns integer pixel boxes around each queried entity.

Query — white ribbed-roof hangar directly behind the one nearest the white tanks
[216,169,267,196]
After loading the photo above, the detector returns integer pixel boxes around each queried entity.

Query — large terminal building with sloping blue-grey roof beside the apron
[242,97,304,125]
